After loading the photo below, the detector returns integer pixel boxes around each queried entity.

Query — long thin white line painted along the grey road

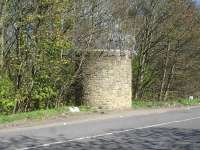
[16,116,200,150]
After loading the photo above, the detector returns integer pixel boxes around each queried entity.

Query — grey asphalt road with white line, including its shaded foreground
[0,108,200,150]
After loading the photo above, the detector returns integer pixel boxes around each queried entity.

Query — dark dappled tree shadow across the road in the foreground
[0,128,200,150]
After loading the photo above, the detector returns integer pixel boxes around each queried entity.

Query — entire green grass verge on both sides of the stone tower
[0,99,200,124]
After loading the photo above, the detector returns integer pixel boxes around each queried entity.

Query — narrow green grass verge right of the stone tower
[132,99,200,109]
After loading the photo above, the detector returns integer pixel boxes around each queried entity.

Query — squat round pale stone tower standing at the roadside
[83,50,132,110]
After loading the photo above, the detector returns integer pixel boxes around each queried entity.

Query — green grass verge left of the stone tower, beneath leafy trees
[0,106,94,124]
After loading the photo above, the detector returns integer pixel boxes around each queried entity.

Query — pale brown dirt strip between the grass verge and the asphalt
[0,106,200,133]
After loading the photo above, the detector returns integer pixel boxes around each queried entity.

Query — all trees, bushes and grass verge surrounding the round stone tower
[0,0,200,116]
